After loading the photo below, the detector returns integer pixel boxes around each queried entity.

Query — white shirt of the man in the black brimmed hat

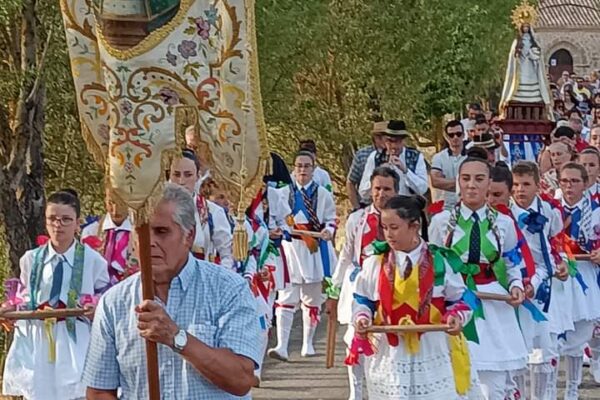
[358,149,429,199]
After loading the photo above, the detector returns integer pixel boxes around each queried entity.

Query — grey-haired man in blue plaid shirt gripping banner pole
[83,184,262,400]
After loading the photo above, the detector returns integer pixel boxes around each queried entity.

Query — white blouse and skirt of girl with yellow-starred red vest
[353,242,482,400]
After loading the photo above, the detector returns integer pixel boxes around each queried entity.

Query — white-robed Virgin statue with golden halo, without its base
[500,1,552,116]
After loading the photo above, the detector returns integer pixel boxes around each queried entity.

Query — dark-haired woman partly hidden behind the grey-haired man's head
[169,149,234,269]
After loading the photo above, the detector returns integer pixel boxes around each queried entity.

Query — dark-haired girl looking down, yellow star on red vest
[346,196,480,400]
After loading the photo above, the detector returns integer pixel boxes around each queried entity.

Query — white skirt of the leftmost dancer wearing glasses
[2,320,90,400]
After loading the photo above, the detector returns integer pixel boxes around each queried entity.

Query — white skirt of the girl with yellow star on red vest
[365,332,482,400]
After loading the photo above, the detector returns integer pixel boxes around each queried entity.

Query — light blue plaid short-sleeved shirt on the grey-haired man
[83,255,262,400]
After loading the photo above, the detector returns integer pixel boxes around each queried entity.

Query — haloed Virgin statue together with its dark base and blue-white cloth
[499,0,554,163]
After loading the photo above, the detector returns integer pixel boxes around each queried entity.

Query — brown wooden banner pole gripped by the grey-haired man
[135,223,160,400]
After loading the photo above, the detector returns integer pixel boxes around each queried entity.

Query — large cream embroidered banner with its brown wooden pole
[51,0,270,400]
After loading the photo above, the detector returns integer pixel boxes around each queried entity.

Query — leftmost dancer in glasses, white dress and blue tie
[2,191,109,400]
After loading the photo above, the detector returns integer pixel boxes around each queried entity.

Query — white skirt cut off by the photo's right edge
[571,261,600,322]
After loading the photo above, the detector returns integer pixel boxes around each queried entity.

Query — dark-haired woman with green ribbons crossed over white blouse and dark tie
[429,158,527,400]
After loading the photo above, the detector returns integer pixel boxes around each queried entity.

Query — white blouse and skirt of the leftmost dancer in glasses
[2,242,109,400]
